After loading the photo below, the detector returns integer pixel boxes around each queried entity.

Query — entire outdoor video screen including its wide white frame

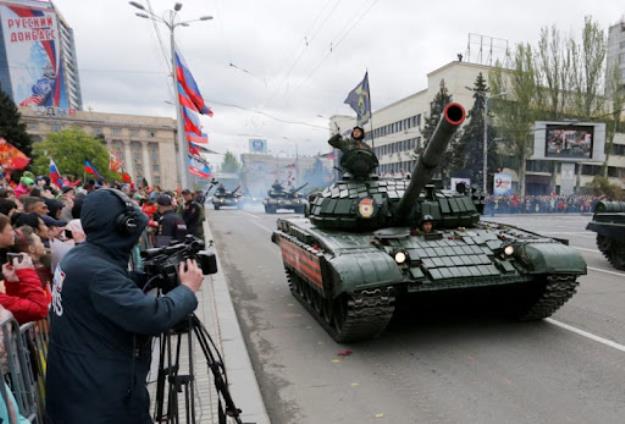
[531,121,605,162]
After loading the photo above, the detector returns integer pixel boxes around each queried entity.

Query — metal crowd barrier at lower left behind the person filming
[0,315,48,424]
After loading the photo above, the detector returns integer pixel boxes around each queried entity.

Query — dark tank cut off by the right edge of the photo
[586,200,625,271]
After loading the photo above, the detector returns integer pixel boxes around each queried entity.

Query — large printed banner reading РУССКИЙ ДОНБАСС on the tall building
[0,1,69,109]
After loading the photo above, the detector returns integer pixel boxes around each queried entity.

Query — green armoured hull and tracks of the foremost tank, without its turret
[272,218,586,342]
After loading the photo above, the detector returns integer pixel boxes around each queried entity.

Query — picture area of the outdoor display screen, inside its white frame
[545,125,594,159]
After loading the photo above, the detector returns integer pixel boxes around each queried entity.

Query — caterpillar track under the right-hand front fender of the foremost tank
[517,275,579,321]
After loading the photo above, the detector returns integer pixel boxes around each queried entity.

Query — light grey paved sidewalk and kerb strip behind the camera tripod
[148,221,270,424]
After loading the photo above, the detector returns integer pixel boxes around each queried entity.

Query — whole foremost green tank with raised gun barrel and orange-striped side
[271,103,586,343]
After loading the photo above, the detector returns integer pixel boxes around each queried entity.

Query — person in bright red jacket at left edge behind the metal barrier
[0,253,50,324]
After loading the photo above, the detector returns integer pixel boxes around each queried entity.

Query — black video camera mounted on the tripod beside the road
[141,235,217,293]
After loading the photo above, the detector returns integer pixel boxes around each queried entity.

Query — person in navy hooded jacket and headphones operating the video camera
[46,189,203,424]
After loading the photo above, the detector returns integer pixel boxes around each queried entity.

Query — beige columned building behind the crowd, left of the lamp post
[20,108,179,189]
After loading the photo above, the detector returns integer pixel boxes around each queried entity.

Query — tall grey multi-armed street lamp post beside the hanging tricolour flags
[129,1,213,189]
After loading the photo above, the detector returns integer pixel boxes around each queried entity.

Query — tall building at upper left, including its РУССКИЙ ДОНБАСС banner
[0,0,82,110]
